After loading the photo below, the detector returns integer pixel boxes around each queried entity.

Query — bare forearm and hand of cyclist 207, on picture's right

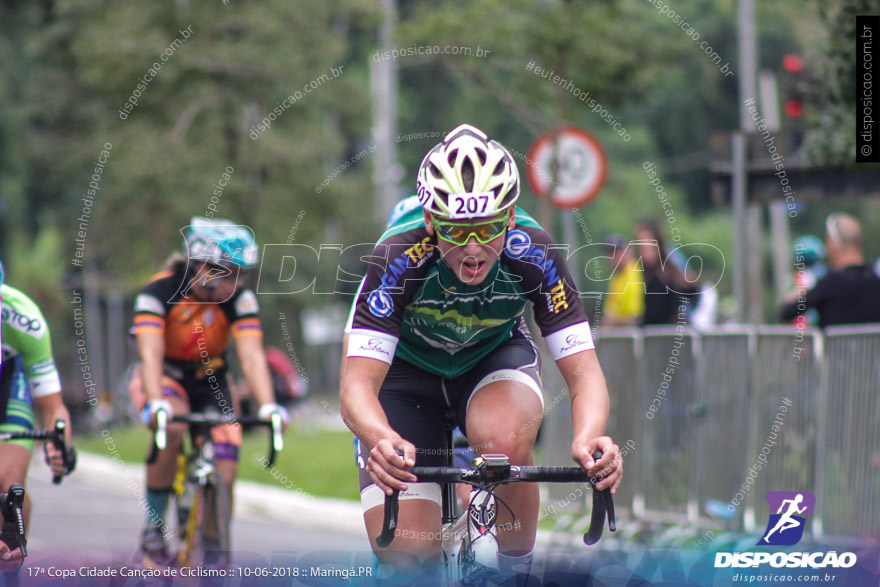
[556,349,623,493]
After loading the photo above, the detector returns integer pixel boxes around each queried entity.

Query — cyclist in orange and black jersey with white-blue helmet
[129,217,289,566]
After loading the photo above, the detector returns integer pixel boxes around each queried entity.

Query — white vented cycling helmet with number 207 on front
[418,124,519,220]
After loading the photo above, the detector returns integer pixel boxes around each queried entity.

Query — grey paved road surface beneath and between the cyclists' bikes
[10,455,624,587]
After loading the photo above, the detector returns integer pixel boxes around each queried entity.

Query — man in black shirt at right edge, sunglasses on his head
[780,213,880,328]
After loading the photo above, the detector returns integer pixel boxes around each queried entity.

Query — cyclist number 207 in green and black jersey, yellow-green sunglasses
[341,124,623,574]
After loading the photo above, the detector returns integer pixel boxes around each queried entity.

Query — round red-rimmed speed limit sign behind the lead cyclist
[526,127,607,209]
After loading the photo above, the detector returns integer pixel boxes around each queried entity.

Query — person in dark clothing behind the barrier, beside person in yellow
[636,220,699,326]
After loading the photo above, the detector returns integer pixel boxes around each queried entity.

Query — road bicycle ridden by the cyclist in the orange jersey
[151,409,284,568]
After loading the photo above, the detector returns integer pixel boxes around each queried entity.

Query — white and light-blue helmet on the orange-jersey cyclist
[186,216,259,269]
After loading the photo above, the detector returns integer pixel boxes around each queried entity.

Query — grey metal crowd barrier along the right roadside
[542,325,880,540]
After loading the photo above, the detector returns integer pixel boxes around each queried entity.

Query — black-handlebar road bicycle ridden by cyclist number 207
[376,451,617,585]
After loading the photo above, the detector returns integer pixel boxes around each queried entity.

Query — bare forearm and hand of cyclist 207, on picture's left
[339,357,417,494]
